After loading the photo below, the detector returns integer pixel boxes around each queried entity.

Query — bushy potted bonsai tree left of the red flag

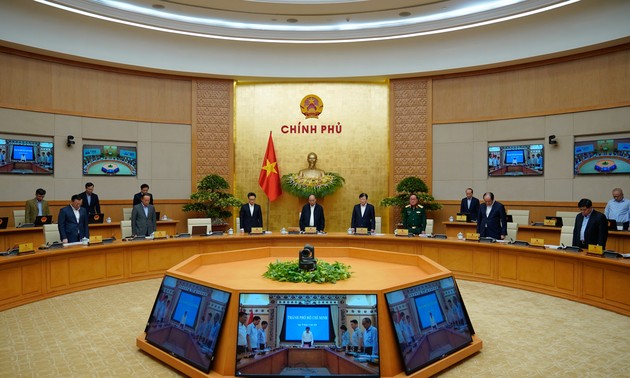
[182,174,242,231]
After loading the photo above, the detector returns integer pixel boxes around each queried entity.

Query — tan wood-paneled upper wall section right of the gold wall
[432,45,630,124]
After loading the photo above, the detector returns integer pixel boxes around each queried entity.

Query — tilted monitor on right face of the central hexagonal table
[385,277,475,374]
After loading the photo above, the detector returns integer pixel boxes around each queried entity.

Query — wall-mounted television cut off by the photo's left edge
[0,135,54,175]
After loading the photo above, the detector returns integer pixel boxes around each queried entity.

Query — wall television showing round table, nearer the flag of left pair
[83,143,138,176]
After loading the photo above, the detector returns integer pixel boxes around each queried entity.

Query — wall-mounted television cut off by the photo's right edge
[573,136,630,175]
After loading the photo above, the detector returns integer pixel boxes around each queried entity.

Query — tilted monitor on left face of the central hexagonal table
[144,276,230,373]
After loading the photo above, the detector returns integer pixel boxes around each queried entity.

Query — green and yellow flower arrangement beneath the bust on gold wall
[280,172,346,198]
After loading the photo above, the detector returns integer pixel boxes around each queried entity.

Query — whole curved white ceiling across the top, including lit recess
[0,0,630,81]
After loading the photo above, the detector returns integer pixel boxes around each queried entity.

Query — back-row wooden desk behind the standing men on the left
[0,219,179,251]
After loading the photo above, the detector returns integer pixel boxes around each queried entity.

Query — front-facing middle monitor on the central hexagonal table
[234,292,380,378]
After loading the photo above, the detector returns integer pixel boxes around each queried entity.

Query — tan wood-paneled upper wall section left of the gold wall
[0,49,192,124]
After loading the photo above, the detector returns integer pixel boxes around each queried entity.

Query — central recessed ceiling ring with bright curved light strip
[35,0,580,43]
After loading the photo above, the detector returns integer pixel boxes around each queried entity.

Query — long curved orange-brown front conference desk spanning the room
[0,233,630,315]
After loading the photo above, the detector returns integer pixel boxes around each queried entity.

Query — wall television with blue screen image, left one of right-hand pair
[488,143,545,177]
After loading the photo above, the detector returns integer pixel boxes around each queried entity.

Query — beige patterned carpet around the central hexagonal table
[0,279,630,377]
